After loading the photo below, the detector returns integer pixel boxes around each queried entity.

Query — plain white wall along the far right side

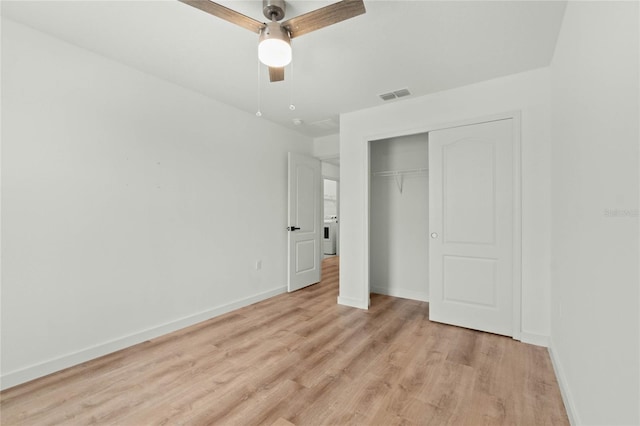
[551,2,640,425]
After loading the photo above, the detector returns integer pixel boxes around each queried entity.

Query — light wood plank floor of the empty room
[0,257,568,426]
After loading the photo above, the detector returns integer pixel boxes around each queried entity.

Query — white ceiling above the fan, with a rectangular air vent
[2,0,565,137]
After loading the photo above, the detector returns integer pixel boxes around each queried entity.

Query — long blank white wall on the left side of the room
[1,20,312,387]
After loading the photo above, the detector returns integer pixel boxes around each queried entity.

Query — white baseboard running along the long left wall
[0,287,287,390]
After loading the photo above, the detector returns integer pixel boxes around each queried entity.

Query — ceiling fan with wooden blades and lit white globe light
[179,0,366,82]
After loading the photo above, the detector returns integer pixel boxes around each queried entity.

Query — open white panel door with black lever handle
[287,152,323,291]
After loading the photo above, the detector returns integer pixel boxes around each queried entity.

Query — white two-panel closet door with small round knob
[429,119,514,336]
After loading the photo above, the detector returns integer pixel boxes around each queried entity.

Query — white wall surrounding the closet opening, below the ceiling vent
[339,68,550,344]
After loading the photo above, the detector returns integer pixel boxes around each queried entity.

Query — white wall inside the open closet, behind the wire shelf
[369,134,429,301]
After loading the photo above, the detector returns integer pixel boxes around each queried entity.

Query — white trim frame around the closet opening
[362,111,522,340]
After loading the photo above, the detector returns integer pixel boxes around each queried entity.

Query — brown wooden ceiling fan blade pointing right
[282,0,366,38]
